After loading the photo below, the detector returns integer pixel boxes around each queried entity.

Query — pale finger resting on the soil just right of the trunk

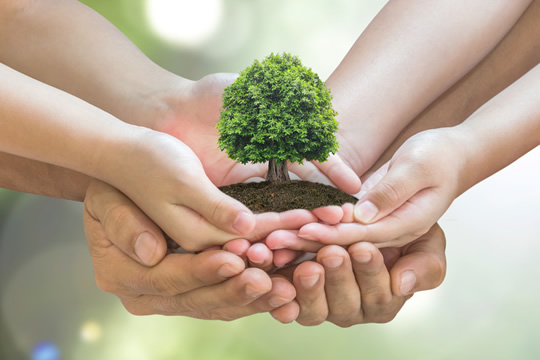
[313,154,362,194]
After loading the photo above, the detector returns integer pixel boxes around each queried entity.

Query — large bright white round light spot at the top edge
[145,0,223,46]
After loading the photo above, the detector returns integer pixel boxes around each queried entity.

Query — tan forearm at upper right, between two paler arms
[369,1,540,173]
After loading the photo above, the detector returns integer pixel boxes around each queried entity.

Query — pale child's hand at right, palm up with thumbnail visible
[297,128,467,247]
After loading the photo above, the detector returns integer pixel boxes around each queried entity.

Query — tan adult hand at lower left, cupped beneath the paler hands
[84,182,297,322]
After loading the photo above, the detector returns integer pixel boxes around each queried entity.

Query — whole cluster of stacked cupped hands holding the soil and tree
[84,74,448,326]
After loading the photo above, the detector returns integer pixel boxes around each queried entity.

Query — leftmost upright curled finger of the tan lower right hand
[293,261,328,326]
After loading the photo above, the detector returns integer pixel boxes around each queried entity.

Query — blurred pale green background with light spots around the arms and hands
[0,0,540,360]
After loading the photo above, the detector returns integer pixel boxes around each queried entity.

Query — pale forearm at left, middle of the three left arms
[0,64,141,181]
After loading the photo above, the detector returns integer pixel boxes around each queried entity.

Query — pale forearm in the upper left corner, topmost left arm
[0,0,188,128]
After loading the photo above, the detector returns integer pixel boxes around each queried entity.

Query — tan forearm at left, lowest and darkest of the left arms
[0,153,92,201]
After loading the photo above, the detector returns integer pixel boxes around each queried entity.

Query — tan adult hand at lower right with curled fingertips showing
[273,225,446,327]
